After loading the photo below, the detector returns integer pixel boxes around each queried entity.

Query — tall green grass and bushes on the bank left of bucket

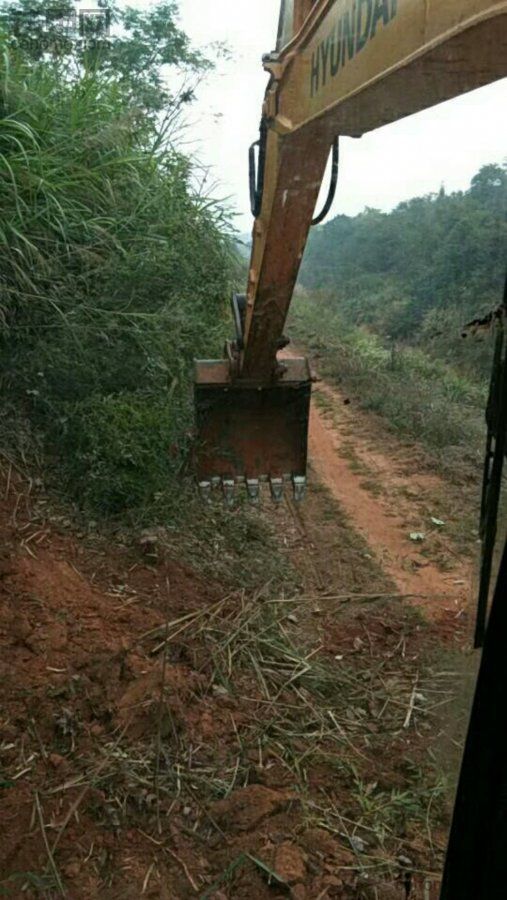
[0,42,235,514]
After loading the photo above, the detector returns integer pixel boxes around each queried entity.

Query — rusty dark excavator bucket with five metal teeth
[195,359,311,503]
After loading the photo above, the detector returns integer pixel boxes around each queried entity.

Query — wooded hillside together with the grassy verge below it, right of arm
[291,163,507,470]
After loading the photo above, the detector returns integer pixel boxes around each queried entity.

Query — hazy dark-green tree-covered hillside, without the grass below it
[300,164,507,372]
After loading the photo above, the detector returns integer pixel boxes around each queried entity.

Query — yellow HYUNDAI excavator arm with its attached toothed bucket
[195,0,507,501]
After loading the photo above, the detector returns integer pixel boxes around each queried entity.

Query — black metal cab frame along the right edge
[440,272,507,900]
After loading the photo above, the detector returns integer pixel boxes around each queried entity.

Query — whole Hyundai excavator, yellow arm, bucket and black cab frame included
[195,0,507,900]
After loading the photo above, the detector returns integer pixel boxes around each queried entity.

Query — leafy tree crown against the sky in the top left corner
[0,0,212,114]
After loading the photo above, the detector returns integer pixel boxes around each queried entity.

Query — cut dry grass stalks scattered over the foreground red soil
[19,587,455,883]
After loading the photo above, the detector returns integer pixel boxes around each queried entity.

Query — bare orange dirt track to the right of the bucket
[309,370,472,612]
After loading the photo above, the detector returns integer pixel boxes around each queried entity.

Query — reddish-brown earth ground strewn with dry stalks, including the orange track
[0,368,480,900]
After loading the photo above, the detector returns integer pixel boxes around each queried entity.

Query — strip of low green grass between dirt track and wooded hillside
[291,292,487,472]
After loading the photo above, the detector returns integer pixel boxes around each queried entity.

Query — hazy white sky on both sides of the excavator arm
[136,0,507,231]
